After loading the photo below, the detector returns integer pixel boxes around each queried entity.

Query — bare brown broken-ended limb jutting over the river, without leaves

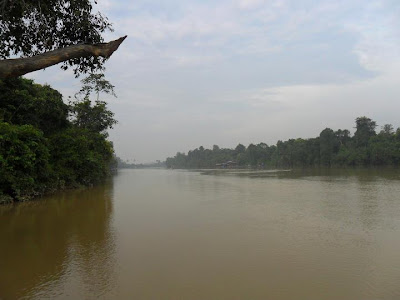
[0,36,126,78]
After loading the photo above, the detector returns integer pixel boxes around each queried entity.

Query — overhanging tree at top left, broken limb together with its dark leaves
[0,0,126,78]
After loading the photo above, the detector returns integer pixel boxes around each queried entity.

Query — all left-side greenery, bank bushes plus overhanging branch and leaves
[0,0,126,203]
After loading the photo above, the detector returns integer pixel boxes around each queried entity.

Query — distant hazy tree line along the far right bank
[166,117,400,168]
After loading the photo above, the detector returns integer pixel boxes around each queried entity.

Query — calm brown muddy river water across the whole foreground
[0,170,400,300]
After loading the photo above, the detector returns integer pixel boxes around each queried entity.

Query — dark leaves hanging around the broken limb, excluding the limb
[0,0,112,74]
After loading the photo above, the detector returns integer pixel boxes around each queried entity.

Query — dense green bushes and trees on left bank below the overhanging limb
[0,75,116,203]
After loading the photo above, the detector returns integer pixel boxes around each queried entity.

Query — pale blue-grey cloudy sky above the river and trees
[27,0,400,163]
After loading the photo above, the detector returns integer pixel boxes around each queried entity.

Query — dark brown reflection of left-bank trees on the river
[0,184,115,299]
